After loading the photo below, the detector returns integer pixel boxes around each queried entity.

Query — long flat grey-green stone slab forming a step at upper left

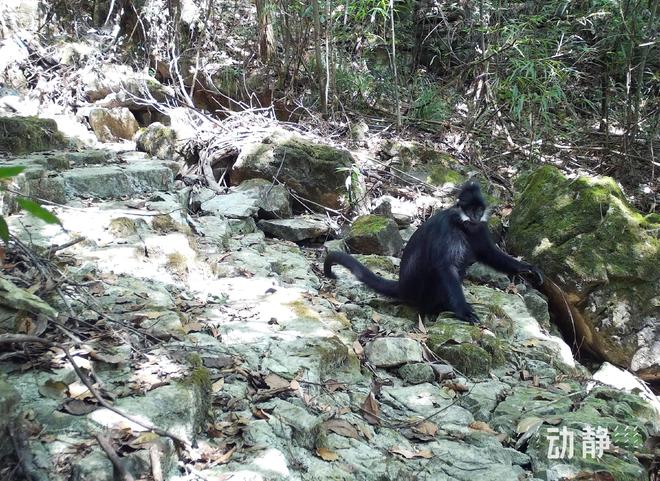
[62,162,174,199]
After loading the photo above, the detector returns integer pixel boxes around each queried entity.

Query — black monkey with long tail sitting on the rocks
[323,181,543,323]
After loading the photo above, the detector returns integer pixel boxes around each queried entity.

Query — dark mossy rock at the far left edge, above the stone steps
[0,117,67,154]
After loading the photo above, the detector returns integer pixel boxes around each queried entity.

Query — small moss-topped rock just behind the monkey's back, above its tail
[346,215,403,255]
